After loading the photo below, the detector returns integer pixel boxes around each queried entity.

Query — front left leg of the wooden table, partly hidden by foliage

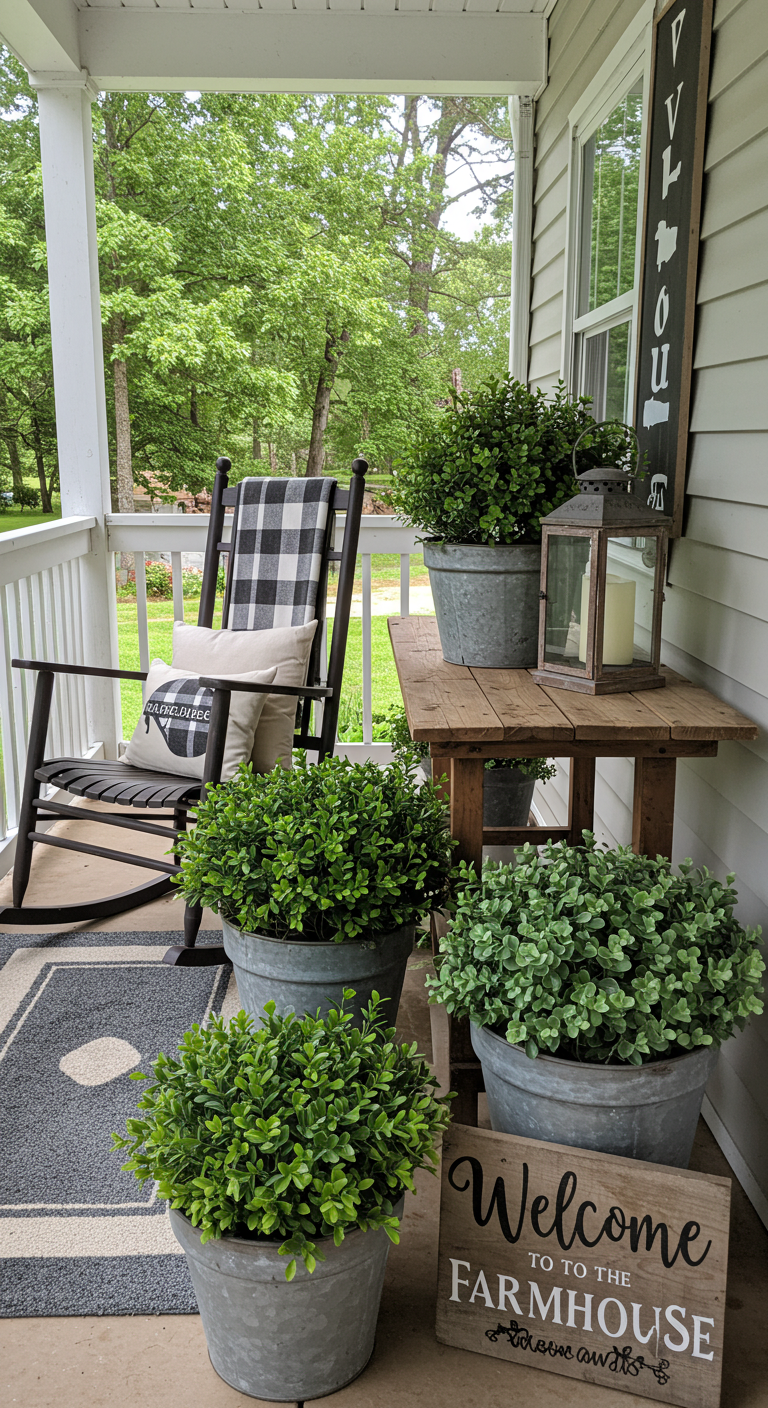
[448,758,485,1125]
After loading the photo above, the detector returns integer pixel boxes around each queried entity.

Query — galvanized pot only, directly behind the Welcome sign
[472,1022,719,1169]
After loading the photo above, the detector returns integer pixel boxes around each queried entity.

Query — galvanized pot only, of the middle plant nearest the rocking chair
[221,918,416,1026]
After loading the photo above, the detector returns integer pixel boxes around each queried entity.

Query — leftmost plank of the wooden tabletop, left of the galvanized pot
[388,617,504,742]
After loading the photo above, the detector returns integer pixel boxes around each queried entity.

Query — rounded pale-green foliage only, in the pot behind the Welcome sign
[427,831,765,1066]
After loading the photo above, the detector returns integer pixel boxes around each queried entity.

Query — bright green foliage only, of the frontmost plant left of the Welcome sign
[113,991,448,1281]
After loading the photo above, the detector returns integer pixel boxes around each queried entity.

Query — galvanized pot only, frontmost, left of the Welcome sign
[171,1200,403,1402]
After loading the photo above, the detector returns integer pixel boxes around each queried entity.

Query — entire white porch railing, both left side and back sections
[0,514,421,876]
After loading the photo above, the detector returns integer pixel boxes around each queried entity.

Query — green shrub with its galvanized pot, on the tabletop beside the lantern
[390,377,628,669]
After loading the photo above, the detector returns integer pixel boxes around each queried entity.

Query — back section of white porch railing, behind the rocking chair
[107,514,421,756]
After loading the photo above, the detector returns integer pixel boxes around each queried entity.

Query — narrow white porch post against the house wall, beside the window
[509,97,534,382]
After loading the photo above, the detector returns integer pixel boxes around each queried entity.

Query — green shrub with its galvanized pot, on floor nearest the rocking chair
[178,755,452,1022]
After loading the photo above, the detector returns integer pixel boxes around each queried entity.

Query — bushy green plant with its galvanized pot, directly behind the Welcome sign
[427,832,765,1167]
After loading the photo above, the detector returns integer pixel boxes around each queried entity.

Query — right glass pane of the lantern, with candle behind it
[603,534,657,674]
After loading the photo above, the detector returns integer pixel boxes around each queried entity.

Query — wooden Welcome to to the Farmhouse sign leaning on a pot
[437,1125,730,1408]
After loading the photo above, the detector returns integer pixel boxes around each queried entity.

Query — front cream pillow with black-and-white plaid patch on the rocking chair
[123,660,275,781]
